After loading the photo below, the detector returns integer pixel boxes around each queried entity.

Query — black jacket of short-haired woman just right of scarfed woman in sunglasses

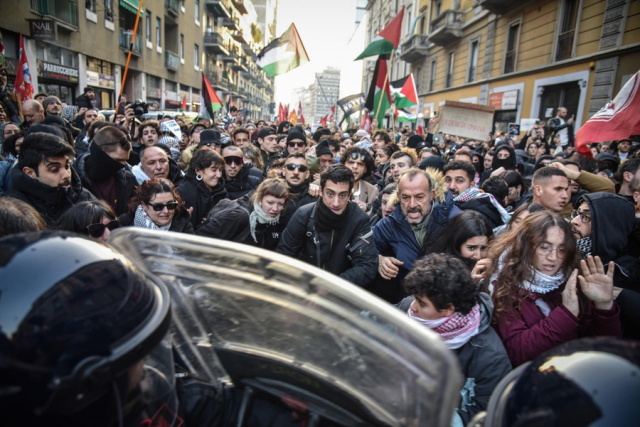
[176,170,228,229]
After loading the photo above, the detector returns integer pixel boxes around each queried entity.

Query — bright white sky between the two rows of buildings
[275,0,366,110]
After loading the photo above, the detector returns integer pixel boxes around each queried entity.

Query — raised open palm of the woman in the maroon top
[578,256,615,310]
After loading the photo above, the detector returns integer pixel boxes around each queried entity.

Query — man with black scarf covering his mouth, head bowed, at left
[77,125,137,216]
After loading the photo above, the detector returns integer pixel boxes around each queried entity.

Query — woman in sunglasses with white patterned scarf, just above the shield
[118,178,193,234]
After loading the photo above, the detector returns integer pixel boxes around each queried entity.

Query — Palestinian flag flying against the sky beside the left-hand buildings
[256,23,309,77]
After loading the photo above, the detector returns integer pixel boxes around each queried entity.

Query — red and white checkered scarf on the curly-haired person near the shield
[407,304,480,350]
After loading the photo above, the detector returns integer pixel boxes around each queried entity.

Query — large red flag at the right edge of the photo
[576,71,640,157]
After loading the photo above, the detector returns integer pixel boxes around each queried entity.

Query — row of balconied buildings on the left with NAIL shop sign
[0,0,273,118]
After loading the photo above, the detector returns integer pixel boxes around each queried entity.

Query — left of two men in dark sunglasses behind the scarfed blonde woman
[222,145,262,200]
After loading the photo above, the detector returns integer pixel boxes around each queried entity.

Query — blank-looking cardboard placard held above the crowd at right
[438,101,495,141]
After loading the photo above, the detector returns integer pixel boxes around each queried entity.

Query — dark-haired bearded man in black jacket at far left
[7,131,95,226]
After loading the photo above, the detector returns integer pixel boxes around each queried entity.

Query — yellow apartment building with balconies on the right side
[365,0,640,134]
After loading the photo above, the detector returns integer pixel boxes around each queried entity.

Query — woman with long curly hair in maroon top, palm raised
[485,210,621,366]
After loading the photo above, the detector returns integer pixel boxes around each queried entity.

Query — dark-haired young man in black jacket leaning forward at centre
[277,165,378,286]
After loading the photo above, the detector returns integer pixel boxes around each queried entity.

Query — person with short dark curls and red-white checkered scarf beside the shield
[398,253,511,425]
